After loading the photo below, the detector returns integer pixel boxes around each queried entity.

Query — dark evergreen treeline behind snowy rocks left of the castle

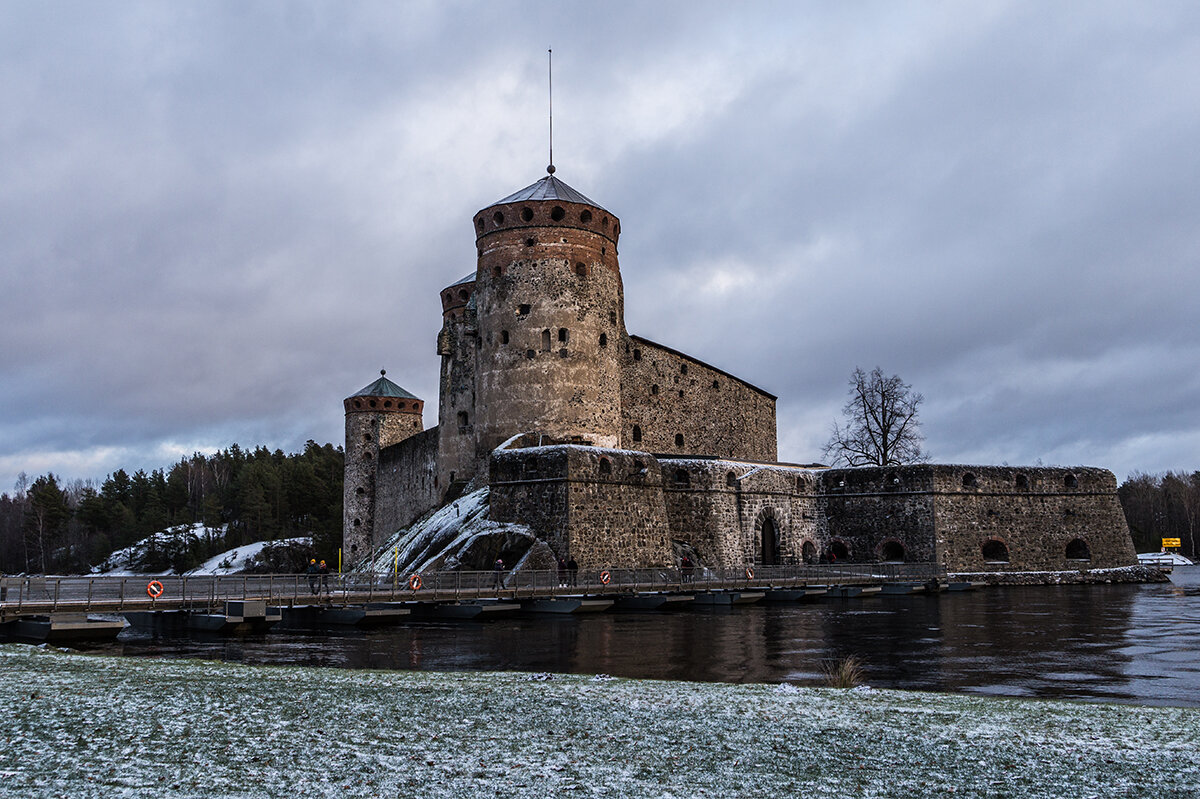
[0,440,344,573]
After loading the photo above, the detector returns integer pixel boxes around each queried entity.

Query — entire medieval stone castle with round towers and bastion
[344,167,1136,572]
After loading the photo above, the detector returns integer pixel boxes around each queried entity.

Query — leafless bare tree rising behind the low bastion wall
[824,366,929,465]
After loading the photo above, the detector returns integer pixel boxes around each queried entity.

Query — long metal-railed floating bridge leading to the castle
[0,563,944,618]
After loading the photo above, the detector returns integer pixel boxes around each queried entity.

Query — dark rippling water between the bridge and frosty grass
[84,566,1200,707]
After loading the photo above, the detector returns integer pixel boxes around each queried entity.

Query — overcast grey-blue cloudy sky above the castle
[0,0,1200,491]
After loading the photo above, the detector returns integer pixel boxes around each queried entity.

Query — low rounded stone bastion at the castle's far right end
[822,464,1136,571]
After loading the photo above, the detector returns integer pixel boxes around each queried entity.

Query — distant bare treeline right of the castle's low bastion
[1117,471,1200,559]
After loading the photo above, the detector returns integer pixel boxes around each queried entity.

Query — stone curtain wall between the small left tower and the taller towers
[372,427,446,548]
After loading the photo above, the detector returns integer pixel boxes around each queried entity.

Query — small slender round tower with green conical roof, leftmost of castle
[342,370,425,563]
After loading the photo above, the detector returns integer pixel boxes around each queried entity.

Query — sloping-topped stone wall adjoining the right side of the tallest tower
[620,336,776,462]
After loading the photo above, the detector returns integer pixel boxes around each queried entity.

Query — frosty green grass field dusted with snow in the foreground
[0,644,1200,799]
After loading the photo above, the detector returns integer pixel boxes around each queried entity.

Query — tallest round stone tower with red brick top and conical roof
[473,174,625,456]
